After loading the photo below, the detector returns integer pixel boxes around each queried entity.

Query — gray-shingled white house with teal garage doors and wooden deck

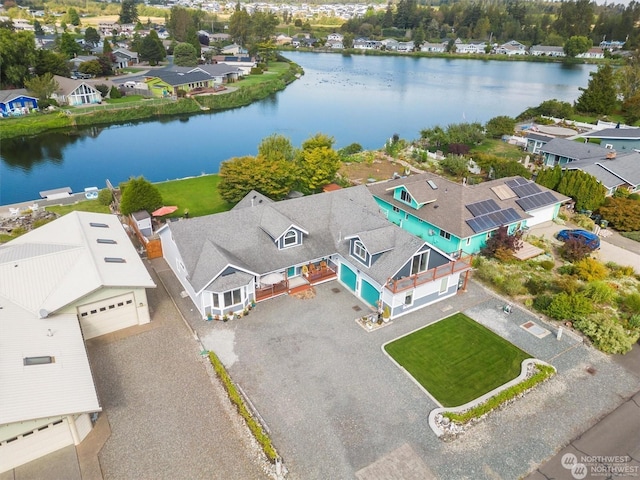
[158,186,471,318]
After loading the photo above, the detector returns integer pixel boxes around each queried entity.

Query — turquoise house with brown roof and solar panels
[368,173,570,257]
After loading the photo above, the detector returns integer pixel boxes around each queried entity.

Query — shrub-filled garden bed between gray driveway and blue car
[473,237,640,353]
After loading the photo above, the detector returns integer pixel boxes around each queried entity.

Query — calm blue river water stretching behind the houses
[0,52,596,204]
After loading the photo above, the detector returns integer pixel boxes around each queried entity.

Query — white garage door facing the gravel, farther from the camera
[78,293,138,340]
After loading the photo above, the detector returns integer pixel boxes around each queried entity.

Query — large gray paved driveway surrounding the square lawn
[172,274,637,480]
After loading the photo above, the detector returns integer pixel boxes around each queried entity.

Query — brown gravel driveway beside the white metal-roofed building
[87,260,267,480]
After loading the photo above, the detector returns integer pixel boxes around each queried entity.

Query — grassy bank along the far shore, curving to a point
[0,61,302,139]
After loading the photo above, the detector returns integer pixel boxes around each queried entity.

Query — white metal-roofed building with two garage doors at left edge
[0,212,155,473]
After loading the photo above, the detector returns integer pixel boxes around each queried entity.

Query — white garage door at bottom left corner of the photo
[0,418,73,472]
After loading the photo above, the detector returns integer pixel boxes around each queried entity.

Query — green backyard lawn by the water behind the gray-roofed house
[155,175,233,217]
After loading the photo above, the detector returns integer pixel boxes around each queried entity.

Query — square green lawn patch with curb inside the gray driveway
[385,313,531,407]
